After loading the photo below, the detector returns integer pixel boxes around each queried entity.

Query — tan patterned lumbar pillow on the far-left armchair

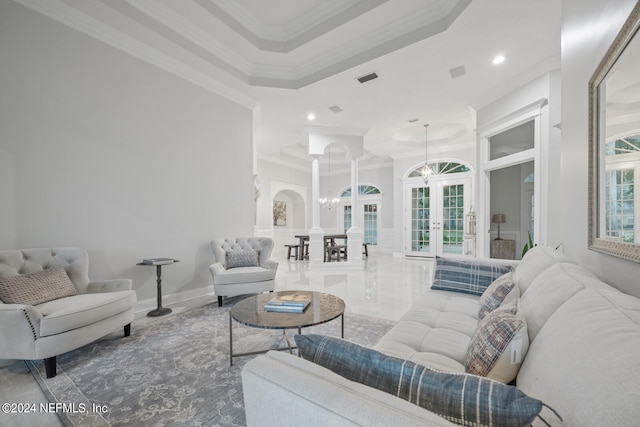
[0,266,78,305]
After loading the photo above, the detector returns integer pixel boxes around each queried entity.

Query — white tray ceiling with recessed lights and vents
[14,0,561,170]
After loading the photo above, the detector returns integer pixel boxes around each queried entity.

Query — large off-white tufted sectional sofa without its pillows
[242,247,640,427]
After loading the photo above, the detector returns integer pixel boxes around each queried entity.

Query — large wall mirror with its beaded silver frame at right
[589,2,640,263]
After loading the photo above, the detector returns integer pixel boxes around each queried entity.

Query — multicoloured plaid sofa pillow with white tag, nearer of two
[465,300,529,383]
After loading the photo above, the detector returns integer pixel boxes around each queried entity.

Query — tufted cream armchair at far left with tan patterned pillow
[0,248,136,378]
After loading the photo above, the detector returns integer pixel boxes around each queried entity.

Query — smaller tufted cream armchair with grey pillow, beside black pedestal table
[209,237,278,307]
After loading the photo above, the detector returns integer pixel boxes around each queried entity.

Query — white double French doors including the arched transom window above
[404,160,473,257]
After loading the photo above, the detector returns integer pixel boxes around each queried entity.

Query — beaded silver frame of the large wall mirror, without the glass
[588,2,640,263]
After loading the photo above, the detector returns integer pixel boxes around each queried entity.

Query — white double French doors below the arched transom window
[405,177,471,257]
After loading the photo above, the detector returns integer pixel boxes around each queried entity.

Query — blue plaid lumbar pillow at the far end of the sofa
[431,257,512,295]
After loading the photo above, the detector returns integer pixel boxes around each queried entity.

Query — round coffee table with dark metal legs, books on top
[229,291,344,365]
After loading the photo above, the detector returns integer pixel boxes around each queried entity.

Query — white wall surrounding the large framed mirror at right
[550,0,640,296]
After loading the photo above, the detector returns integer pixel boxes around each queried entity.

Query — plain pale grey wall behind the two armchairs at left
[0,1,253,300]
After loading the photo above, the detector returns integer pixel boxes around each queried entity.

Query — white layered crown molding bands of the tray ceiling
[14,0,471,89]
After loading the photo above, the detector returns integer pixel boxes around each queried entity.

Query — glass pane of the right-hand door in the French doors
[442,184,464,254]
